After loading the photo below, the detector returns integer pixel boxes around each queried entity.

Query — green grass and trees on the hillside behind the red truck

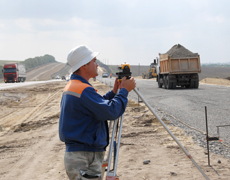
[0,54,57,78]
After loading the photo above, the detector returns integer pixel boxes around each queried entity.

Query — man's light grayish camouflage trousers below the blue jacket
[64,151,104,180]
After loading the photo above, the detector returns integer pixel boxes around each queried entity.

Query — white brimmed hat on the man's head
[67,45,99,72]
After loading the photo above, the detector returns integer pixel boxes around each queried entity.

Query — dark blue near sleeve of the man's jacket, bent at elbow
[81,87,128,121]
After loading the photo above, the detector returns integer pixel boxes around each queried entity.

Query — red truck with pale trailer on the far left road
[2,63,26,83]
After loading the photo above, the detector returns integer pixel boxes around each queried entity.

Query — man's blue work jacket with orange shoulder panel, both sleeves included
[59,74,128,152]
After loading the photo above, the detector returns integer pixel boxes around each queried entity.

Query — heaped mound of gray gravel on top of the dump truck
[162,44,198,58]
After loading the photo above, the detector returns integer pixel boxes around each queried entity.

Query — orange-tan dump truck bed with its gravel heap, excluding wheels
[159,44,201,74]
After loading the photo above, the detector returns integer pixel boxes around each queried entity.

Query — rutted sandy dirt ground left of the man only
[0,82,64,179]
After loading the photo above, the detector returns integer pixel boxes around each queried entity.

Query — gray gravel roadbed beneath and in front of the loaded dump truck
[99,78,230,145]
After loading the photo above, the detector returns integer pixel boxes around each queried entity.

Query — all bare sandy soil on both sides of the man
[0,81,230,180]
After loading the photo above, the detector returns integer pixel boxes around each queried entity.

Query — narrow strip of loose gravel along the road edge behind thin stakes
[156,110,230,159]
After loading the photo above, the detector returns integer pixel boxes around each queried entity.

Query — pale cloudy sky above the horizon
[0,0,230,65]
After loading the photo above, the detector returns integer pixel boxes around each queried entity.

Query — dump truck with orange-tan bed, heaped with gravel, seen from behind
[156,44,201,89]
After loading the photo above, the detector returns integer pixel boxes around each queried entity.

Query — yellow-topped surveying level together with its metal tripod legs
[101,63,209,180]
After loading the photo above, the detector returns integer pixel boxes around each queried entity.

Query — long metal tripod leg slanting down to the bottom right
[134,88,209,180]
